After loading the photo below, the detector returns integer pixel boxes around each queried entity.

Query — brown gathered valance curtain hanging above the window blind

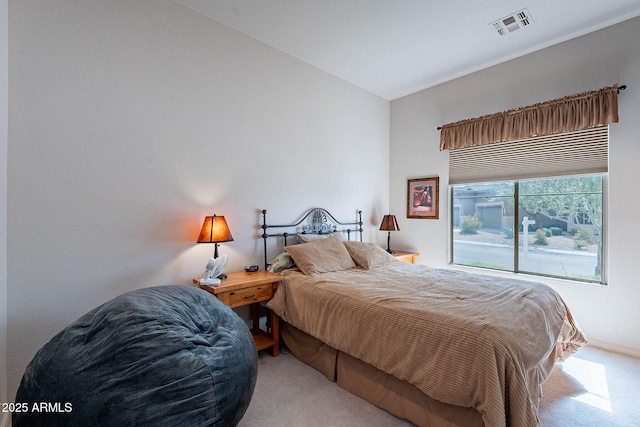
[440,84,618,150]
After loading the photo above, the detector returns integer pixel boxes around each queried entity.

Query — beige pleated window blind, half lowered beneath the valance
[449,126,609,184]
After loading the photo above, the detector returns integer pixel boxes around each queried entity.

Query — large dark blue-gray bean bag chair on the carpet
[12,286,258,427]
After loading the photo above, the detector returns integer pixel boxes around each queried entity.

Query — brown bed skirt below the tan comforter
[280,320,483,427]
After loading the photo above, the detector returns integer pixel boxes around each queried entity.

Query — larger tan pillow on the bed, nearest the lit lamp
[284,235,356,276]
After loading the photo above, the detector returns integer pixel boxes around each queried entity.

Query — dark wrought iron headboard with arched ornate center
[261,208,363,270]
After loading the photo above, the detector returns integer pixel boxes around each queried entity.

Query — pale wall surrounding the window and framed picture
[390,15,640,355]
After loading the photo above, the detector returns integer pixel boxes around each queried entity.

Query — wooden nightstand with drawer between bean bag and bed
[193,270,282,357]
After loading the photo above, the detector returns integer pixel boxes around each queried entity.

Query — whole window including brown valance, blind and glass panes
[440,85,625,284]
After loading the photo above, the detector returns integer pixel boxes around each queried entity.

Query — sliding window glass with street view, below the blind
[451,174,606,283]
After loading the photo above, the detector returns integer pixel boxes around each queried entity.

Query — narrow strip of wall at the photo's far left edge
[0,0,9,410]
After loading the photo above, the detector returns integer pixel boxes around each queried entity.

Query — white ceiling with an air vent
[174,0,640,100]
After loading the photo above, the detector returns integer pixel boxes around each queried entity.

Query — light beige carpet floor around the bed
[239,346,640,427]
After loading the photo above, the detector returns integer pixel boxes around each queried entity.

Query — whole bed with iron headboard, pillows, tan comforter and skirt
[262,209,587,427]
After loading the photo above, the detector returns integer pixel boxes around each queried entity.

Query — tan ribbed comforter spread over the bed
[269,262,586,427]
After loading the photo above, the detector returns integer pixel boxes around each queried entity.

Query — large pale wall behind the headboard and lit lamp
[3,0,390,402]
